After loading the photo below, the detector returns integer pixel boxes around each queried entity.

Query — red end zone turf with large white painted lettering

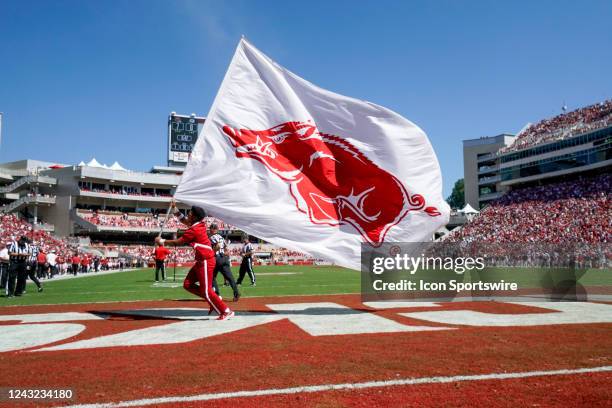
[0,295,612,407]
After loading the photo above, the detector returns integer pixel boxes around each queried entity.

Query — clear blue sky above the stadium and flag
[0,0,612,195]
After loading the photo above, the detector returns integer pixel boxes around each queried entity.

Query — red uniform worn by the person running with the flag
[182,222,229,315]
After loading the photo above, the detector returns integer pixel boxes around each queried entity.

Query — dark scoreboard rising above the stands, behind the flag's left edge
[168,112,206,166]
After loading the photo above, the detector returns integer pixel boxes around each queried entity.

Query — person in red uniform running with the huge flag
[155,200,234,320]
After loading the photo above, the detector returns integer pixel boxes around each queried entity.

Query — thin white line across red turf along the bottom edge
[65,366,612,408]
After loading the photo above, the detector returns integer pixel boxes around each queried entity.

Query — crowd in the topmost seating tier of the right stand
[500,100,612,153]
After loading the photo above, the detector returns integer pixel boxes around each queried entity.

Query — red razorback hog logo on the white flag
[223,122,440,246]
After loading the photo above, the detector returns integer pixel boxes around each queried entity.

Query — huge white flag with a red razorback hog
[175,39,449,269]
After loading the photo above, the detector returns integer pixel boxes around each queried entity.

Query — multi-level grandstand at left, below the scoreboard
[0,155,240,242]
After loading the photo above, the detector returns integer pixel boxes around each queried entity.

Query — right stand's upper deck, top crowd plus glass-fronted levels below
[464,100,612,208]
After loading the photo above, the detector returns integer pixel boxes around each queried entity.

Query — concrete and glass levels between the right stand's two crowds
[463,109,612,209]
